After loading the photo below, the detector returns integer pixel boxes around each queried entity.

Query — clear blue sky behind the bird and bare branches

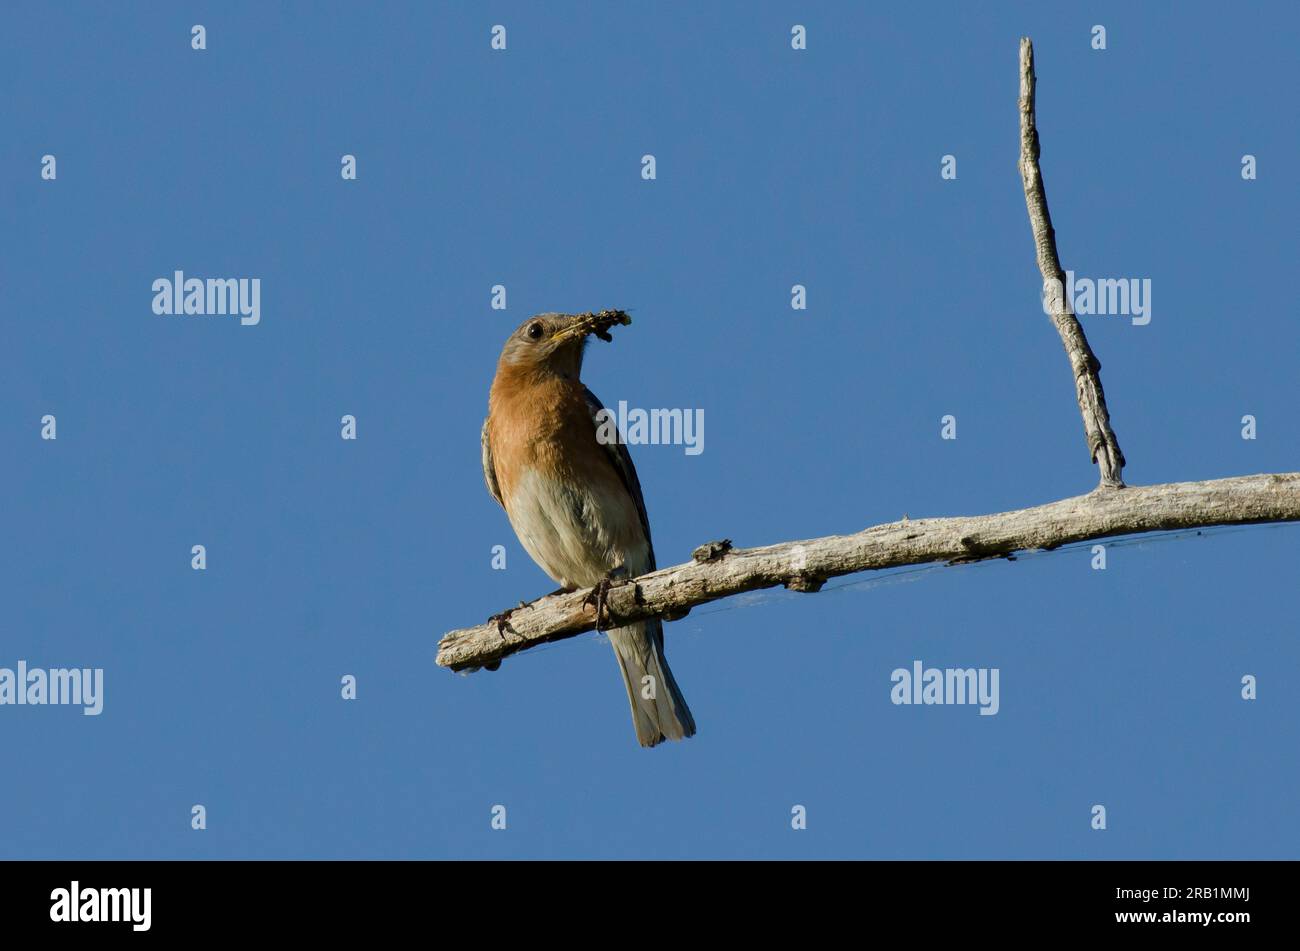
[0,3,1300,857]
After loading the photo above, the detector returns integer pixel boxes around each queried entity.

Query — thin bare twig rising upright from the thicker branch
[1021,36,1125,487]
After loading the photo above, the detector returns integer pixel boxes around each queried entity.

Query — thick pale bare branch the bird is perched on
[438,473,1300,670]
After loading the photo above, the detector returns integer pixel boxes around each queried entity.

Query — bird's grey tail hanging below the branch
[606,618,696,746]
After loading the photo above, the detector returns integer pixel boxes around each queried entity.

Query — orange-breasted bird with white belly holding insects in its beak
[481,311,696,747]
